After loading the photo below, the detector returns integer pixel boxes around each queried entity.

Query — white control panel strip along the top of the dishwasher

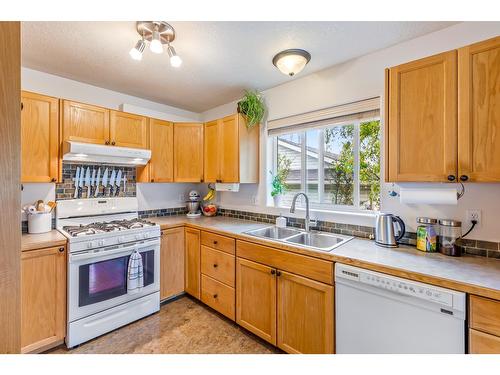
[335,263,465,311]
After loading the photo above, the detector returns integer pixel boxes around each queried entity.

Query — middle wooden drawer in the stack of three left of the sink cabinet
[201,245,235,288]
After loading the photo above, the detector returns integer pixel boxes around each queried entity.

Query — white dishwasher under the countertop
[335,263,466,354]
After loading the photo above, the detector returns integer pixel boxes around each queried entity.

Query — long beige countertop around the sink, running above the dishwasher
[149,216,500,300]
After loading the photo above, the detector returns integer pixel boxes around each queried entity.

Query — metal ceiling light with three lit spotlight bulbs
[129,21,182,68]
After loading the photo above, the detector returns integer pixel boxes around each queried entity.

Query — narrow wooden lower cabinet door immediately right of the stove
[160,227,184,300]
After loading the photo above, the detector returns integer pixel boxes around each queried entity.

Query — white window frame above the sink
[268,116,382,213]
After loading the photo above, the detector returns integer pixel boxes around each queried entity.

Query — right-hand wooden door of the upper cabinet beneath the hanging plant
[219,115,241,182]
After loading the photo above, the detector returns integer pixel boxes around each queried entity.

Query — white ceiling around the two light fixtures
[22,22,453,112]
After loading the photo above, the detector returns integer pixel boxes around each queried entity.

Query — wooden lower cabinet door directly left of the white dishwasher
[277,270,334,354]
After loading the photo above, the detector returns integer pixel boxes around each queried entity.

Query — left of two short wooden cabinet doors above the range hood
[62,100,109,145]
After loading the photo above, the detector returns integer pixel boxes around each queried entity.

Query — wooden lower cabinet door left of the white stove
[21,247,66,353]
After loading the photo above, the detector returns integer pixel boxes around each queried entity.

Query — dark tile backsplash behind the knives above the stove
[56,162,136,200]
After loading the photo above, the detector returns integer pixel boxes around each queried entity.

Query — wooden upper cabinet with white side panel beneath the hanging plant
[204,114,259,183]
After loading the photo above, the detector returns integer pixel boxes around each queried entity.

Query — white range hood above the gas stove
[63,141,151,165]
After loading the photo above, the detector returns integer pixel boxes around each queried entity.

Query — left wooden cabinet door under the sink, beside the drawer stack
[236,258,276,345]
